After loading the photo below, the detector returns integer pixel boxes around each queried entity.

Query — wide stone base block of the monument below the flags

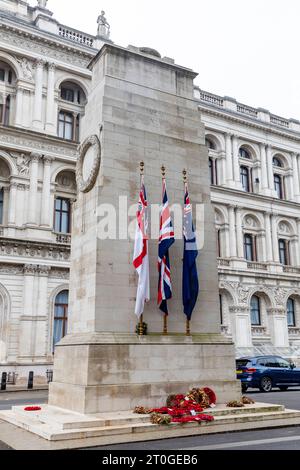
[49,333,241,414]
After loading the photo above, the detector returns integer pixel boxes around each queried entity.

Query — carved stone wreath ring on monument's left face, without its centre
[76,135,101,193]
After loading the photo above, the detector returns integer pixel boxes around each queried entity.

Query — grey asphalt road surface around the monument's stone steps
[0,388,300,451]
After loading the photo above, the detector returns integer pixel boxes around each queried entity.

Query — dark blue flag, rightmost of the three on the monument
[182,184,199,320]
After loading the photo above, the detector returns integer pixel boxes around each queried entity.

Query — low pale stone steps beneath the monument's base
[0,406,300,446]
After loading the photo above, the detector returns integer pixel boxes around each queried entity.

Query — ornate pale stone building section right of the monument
[195,88,300,362]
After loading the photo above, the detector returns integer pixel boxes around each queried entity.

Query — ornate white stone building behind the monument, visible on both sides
[0,0,300,382]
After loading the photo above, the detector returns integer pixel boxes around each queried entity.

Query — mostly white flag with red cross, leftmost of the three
[133,177,150,318]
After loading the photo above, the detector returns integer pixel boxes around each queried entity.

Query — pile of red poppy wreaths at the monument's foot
[134,387,217,425]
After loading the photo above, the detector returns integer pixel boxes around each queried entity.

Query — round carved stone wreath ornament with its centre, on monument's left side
[76,135,101,193]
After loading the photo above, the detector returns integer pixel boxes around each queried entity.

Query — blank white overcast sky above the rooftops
[30,0,300,120]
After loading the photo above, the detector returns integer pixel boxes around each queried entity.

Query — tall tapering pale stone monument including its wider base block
[49,44,240,414]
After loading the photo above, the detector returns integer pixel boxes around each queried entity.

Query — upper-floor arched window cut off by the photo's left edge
[0,61,16,126]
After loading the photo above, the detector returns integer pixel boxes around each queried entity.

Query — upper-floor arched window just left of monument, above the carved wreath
[58,81,86,142]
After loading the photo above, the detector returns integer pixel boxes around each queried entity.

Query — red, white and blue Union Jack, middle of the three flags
[157,179,175,315]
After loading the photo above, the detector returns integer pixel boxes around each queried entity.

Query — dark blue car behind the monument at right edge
[236,356,300,392]
